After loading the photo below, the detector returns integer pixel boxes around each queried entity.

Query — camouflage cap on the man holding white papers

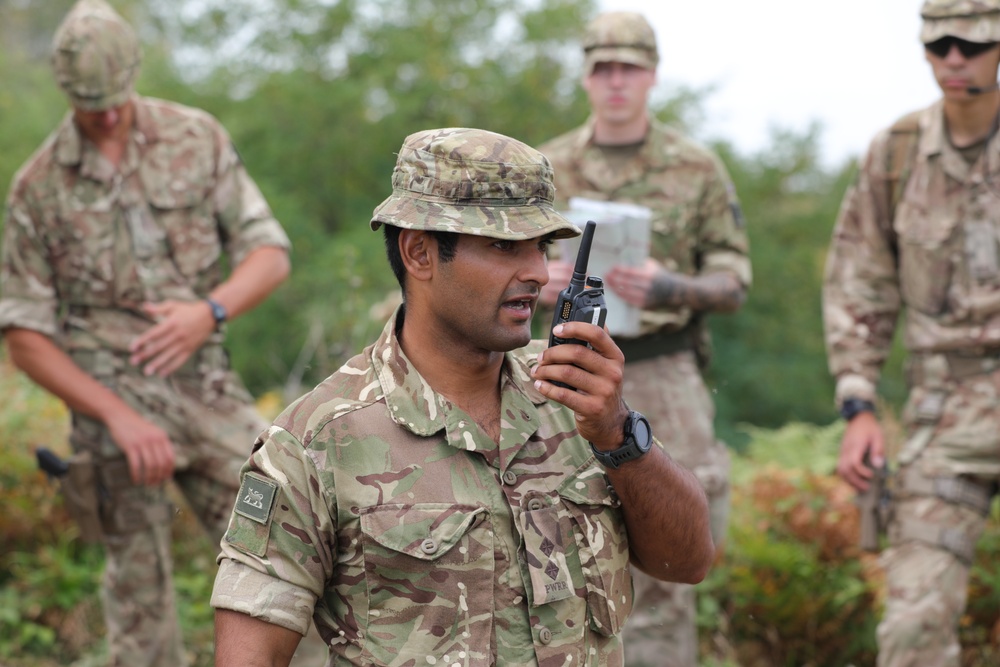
[583,12,660,74]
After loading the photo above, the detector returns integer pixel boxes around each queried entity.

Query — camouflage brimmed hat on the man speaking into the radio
[371,128,580,241]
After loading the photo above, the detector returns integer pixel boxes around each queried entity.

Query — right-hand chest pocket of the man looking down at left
[140,137,222,278]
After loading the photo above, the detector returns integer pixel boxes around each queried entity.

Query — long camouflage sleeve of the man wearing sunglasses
[823,131,901,403]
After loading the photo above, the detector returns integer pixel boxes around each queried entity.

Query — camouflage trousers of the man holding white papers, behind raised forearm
[622,352,729,667]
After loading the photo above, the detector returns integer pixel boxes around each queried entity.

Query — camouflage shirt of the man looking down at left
[0,96,288,352]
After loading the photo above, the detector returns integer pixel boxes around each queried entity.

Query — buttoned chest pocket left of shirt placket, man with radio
[359,503,495,665]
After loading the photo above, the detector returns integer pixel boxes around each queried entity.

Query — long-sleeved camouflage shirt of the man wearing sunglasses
[823,102,1000,402]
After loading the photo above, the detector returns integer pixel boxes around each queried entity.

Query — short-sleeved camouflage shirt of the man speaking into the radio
[212,310,632,667]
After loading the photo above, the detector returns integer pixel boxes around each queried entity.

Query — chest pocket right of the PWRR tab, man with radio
[559,470,632,637]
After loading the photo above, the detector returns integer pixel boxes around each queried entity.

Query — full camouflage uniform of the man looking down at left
[0,2,288,667]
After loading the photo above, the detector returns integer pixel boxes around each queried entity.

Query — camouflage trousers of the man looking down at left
[71,349,326,667]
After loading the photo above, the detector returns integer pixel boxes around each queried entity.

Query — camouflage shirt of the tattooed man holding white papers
[539,118,751,335]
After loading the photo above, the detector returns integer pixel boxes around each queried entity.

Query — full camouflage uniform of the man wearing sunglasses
[823,0,1000,667]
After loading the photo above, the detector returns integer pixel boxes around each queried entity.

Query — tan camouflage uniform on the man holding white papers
[539,15,751,667]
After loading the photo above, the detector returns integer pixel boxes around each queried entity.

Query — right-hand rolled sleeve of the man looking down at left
[213,121,291,265]
